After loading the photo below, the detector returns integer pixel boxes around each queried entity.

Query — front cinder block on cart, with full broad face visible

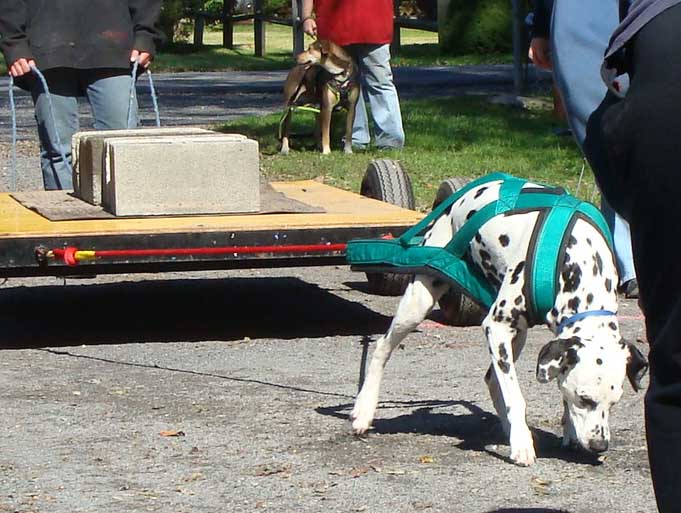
[102,134,260,216]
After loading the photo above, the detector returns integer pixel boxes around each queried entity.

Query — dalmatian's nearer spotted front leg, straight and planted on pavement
[482,308,536,466]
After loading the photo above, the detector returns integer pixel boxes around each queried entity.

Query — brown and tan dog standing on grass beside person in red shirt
[280,40,359,155]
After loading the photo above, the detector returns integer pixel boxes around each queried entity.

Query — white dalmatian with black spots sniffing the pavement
[350,175,648,466]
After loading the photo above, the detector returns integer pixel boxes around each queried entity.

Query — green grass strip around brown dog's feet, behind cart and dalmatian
[220,96,593,210]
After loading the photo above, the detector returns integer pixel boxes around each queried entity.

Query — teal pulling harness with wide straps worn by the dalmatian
[346,173,612,323]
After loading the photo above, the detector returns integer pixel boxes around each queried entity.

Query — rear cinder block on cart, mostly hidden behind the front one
[71,127,245,205]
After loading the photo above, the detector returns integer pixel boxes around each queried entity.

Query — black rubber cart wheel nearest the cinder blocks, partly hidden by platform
[360,159,416,296]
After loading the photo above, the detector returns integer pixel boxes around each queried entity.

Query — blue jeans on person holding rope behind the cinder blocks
[31,68,137,190]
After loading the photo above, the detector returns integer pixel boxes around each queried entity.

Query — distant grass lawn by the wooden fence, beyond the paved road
[154,24,512,71]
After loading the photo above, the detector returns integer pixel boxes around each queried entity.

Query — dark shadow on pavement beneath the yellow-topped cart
[0,277,390,349]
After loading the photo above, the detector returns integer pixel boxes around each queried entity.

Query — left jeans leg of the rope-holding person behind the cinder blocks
[31,68,78,190]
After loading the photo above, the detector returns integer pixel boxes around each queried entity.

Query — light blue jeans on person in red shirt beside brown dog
[345,44,404,148]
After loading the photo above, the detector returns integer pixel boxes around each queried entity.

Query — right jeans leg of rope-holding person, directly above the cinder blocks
[82,69,138,130]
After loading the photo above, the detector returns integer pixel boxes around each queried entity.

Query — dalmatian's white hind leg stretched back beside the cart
[350,275,448,434]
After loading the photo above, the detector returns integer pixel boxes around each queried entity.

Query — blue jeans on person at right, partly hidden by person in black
[551,0,636,284]
